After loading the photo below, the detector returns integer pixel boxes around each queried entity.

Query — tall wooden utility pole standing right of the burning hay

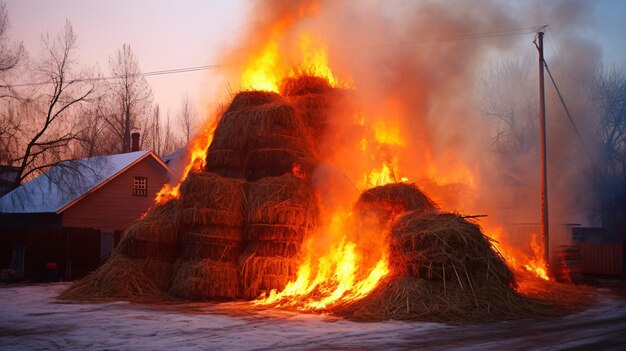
[535,26,550,274]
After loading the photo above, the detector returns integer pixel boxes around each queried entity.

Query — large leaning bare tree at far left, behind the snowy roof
[11,21,95,186]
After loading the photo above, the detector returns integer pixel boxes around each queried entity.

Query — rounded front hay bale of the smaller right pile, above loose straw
[389,211,514,290]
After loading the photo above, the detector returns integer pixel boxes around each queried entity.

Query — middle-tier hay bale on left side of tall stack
[180,172,246,228]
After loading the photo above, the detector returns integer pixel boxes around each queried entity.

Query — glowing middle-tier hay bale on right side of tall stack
[247,174,320,229]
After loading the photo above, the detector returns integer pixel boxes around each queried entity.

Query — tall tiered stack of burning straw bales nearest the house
[61,77,332,300]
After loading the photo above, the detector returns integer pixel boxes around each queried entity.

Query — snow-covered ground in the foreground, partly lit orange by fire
[0,283,626,351]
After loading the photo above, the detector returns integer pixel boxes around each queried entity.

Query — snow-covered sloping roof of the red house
[0,151,171,214]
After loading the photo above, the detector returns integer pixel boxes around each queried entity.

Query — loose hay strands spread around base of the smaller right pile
[330,275,565,324]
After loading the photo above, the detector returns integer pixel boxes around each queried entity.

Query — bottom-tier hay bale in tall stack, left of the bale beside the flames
[169,259,241,300]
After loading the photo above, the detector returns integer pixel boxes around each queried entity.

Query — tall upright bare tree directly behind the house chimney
[106,44,152,152]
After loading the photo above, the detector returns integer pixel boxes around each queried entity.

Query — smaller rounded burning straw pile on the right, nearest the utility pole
[333,184,588,323]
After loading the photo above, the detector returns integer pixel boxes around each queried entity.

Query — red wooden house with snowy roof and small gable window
[0,151,172,280]
